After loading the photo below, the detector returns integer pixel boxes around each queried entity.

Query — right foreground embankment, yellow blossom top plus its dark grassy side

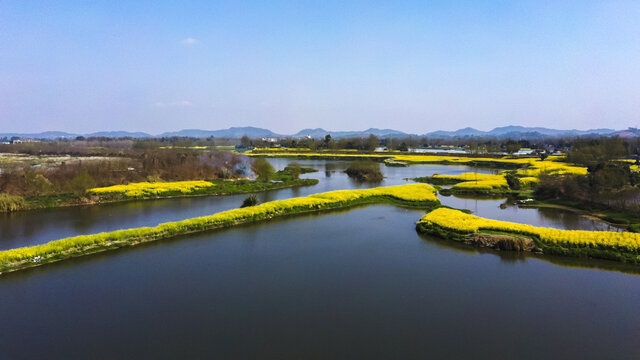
[417,208,640,264]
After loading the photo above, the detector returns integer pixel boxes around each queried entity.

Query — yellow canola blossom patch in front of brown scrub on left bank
[87,180,214,197]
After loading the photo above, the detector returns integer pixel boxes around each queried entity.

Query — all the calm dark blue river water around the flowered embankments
[0,160,640,359]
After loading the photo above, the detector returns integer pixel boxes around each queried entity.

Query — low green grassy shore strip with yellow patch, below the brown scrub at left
[11,168,318,212]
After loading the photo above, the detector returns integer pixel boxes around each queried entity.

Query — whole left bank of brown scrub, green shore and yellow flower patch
[0,149,317,212]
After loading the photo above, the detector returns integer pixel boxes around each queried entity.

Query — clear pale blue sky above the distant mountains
[0,0,640,133]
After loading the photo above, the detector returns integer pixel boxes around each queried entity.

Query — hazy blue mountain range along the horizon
[0,126,640,140]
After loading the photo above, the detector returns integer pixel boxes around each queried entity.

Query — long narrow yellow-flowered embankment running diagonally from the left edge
[0,184,440,273]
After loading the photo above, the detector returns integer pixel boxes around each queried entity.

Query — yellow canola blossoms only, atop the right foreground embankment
[420,208,640,250]
